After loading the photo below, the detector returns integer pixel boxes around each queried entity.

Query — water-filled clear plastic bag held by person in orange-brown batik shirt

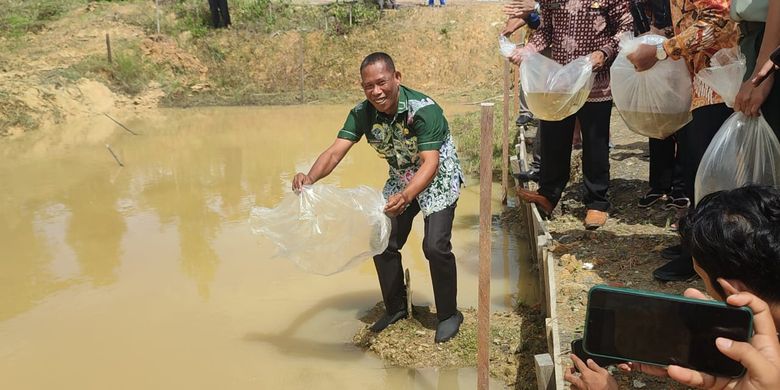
[609,33,692,139]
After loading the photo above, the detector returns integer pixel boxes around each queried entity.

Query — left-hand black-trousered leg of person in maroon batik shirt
[538,115,575,208]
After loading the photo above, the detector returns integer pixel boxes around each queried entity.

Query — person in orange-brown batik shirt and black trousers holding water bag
[628,0,739,281]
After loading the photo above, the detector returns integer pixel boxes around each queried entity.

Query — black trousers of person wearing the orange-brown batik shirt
[676,103,734,207]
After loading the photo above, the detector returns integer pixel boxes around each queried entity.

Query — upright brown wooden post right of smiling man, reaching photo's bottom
[477,103,493,390]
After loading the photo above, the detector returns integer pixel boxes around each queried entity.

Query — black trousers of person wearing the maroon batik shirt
[539,101,612,211]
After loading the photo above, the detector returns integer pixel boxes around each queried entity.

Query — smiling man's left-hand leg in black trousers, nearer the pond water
[374,200,420,314]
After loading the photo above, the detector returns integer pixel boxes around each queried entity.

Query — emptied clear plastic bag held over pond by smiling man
[251,184,390,275]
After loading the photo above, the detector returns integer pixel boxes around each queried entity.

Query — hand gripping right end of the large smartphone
[667,292,780,390]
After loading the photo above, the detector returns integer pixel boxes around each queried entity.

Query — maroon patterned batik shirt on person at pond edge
[527,0,634,102]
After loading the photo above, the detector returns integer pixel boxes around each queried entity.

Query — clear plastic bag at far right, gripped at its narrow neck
[694,49,780,203]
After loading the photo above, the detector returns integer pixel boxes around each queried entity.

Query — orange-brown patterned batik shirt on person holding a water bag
[664,0,736,110]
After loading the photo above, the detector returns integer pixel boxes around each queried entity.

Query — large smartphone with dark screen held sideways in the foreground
[583,286,753,377]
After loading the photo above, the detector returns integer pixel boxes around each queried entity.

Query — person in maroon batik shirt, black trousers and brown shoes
[510,0,633,229]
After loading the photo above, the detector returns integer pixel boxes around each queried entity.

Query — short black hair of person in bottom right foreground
[679,185,780,303]
